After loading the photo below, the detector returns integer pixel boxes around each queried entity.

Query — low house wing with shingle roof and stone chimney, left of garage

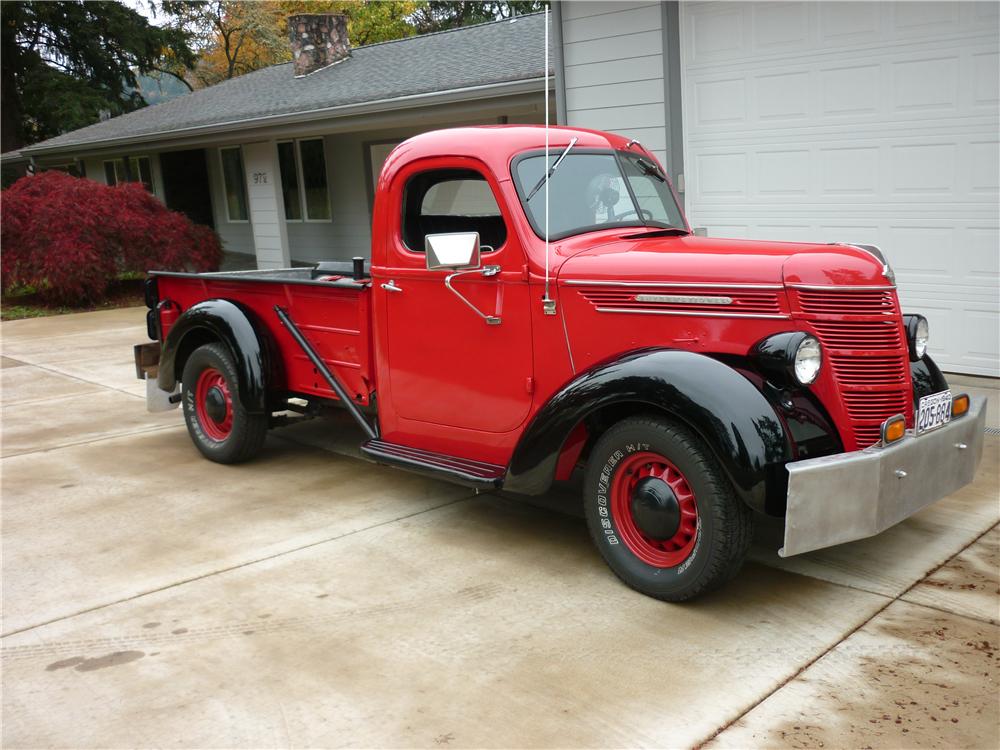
[11,14,554,268]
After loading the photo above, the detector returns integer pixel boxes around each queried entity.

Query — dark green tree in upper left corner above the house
[0,0,194,152]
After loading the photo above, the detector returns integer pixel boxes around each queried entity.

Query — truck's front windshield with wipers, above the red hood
[514,150,685,240]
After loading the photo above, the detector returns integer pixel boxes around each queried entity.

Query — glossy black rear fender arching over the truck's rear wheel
[156,299,274,413]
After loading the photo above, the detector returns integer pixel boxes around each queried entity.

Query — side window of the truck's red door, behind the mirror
[403,169,507,253]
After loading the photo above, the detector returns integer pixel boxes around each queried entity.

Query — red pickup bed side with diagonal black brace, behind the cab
[150,262,375,405]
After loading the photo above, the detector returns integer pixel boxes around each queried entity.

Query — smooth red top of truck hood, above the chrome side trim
[559,235,889,286]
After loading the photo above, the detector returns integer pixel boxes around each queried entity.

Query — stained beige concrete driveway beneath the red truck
[0,309,1000,748]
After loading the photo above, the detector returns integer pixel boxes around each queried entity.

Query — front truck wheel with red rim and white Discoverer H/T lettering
[584,416,753,602]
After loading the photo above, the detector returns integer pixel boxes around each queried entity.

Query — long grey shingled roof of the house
[22,13,545,155]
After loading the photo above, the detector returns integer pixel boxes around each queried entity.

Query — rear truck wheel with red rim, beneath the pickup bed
[181,344,268,464]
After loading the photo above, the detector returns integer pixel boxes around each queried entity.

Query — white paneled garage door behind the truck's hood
[680,2,1000,376]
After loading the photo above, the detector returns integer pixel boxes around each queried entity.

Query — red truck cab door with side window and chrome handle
[377,158,532,433]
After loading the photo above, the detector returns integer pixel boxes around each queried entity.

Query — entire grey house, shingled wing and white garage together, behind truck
[9,0,1000,377]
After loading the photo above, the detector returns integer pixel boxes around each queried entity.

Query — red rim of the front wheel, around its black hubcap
[611,452,698,568]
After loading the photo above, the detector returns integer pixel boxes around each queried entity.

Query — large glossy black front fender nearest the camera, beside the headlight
[504,349,792,511]
